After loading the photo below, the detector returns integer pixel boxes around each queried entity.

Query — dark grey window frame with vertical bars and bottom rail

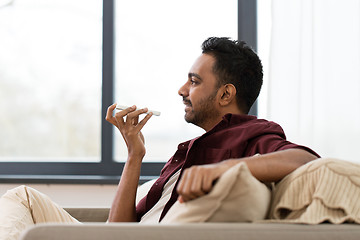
[0,0,257,184]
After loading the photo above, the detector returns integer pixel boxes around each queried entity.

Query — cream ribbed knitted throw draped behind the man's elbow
[269,158,360,224]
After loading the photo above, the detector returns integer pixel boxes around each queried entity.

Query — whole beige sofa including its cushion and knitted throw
[20,159,360,240]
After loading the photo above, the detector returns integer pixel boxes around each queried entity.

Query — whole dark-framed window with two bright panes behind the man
[0,0,256,183]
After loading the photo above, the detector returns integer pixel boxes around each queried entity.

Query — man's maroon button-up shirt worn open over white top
[136,114,319,221]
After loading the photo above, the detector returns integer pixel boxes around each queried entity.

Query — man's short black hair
[201,37,263,113]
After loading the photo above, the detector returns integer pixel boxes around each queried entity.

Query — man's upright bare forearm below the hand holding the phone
[108,157,141,222]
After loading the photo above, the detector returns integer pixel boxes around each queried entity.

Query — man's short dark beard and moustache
[183,91,220,127]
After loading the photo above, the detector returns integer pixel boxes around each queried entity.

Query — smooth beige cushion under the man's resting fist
[161,162,271,223]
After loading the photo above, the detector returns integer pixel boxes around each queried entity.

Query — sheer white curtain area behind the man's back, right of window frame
[258,0,360,163]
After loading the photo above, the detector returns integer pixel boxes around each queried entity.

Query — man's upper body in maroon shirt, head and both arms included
[106,38,319,222]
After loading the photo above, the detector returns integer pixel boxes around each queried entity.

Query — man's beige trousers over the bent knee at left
[0,186,80,240]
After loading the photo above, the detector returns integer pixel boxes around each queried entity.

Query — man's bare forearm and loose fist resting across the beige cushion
[177,149,317,202]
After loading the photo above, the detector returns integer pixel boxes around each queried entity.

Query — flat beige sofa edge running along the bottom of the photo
[20,223,360,240]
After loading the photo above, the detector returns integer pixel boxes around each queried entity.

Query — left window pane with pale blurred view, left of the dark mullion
[0,0,102,161]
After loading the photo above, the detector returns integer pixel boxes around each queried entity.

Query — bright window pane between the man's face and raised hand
[115,0,237,161]
